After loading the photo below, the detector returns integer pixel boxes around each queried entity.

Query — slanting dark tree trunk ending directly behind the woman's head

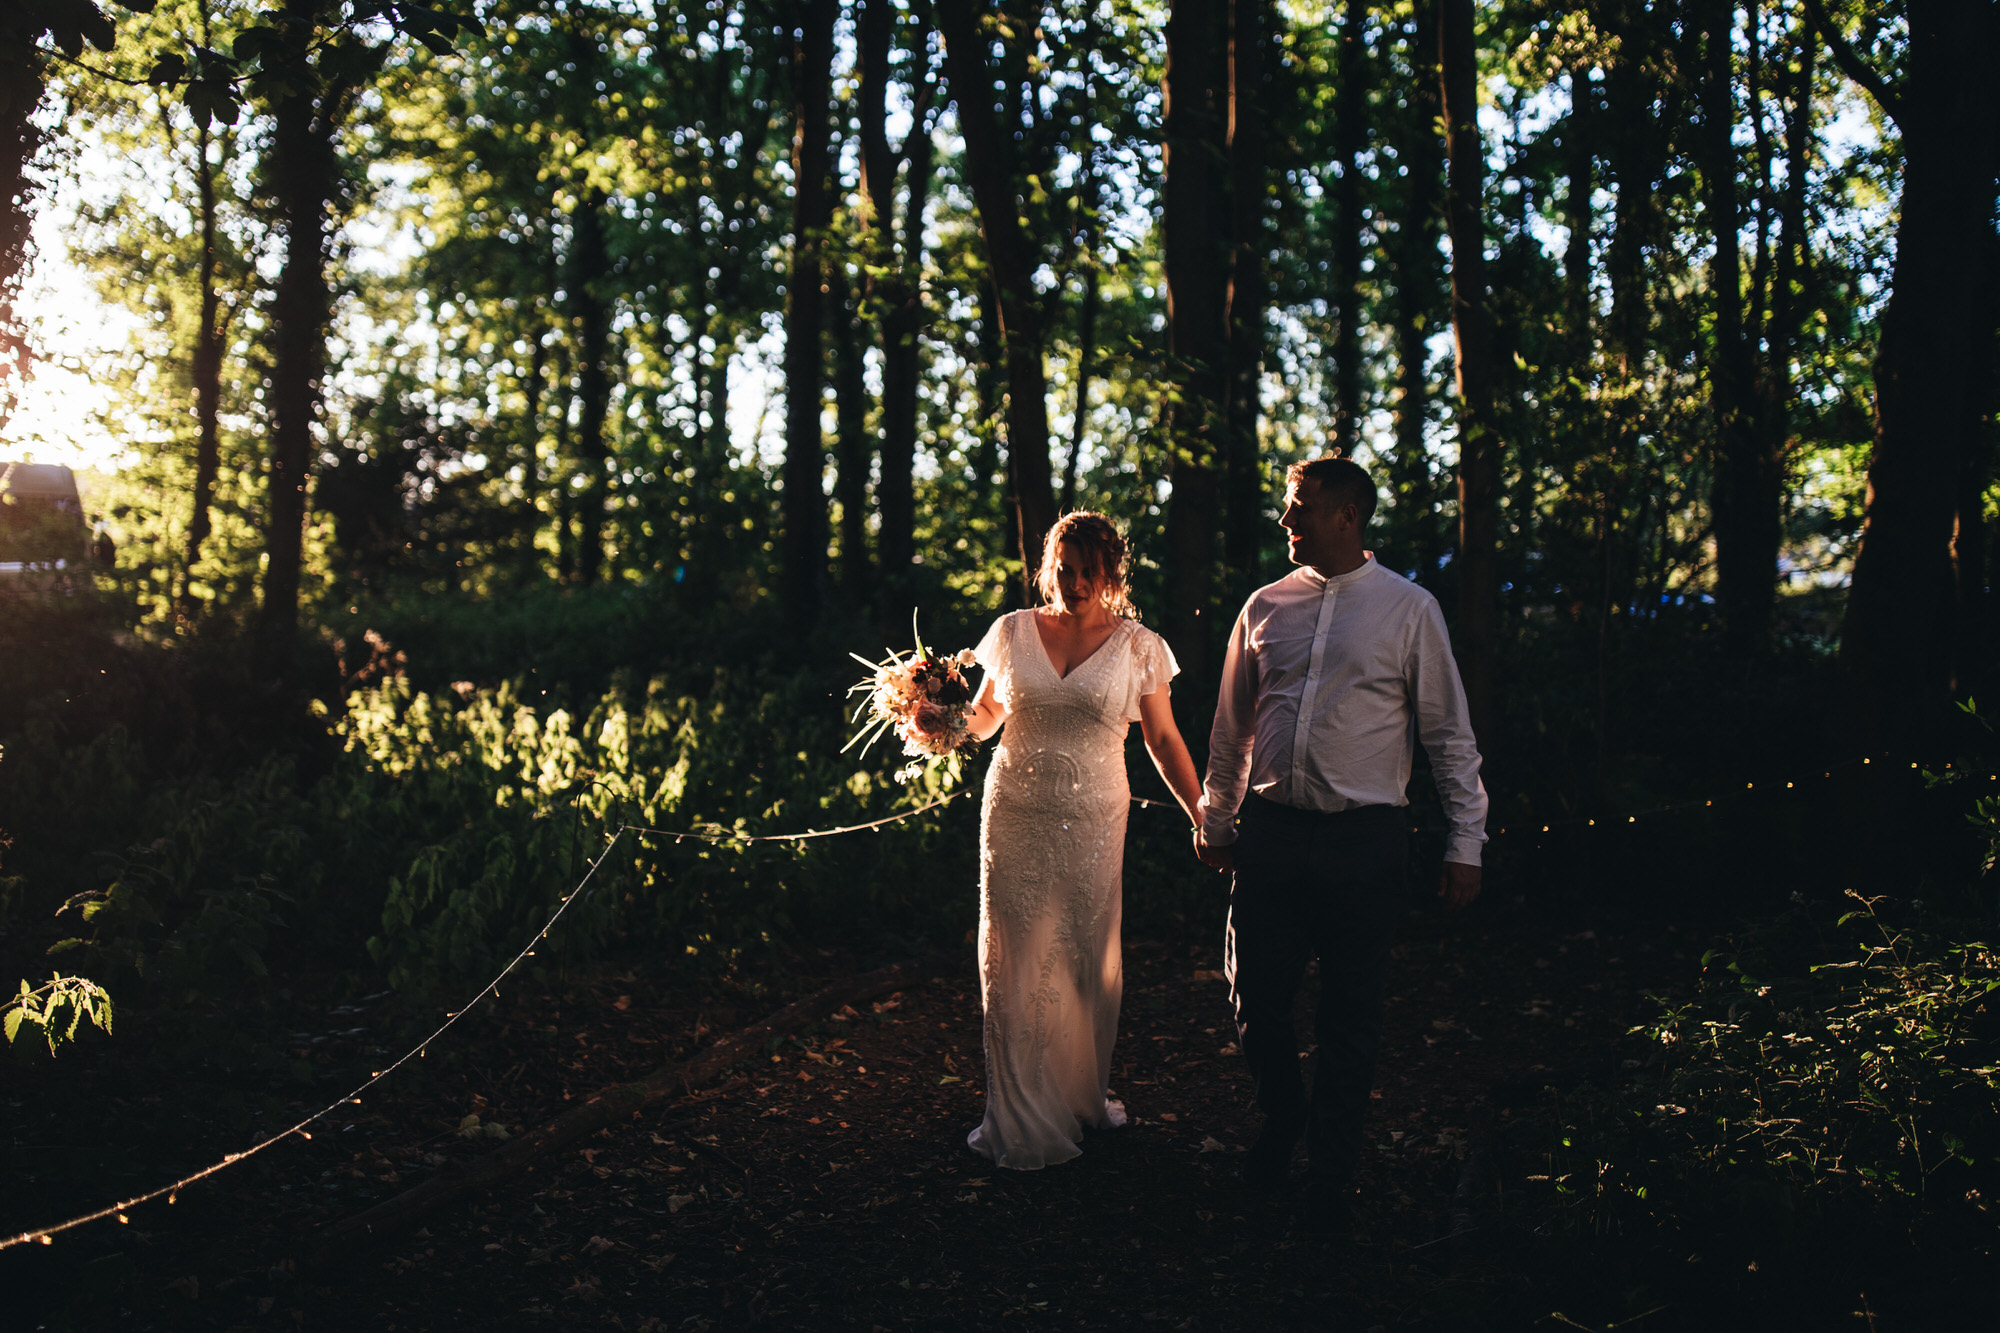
[932,0,1056,598]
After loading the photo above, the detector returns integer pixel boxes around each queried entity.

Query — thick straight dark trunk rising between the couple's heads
[1162,0,1232,681]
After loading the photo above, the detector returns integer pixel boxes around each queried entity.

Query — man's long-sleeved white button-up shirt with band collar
[1202,556,1486,865]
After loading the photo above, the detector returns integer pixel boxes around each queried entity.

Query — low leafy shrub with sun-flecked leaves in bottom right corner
[1548,895,2000,1249]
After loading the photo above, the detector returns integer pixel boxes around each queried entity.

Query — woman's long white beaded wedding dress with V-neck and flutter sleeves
[966,610,1178,1171]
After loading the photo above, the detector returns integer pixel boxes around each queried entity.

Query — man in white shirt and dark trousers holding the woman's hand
[1194,454,1486,1229]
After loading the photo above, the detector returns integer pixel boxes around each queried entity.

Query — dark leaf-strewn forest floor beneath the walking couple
[0,896,1944,1333]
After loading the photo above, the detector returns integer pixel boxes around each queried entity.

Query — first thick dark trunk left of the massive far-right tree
[1698,0,1784,656]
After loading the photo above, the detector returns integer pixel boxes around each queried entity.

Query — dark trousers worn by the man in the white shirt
[1226,795,1410,1181]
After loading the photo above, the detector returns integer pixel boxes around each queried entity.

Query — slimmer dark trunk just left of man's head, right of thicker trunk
[1222,0,1270,602]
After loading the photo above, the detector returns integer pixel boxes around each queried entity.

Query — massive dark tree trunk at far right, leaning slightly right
[1834,0,2000,751]
